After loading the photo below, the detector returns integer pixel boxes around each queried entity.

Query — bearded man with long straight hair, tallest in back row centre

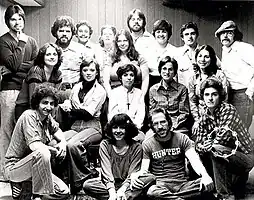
[127,8,159,83]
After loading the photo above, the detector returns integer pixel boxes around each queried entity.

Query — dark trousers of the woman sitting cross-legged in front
[83,174,155,200]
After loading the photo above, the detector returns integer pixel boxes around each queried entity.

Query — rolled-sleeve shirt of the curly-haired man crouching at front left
[5,109,59,167]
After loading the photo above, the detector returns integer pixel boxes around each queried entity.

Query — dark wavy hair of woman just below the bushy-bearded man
[34,42,63,71]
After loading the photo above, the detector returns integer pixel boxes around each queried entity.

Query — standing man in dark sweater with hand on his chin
[0,5,38,180]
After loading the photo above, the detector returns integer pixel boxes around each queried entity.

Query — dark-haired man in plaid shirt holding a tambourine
[194,78,254,199]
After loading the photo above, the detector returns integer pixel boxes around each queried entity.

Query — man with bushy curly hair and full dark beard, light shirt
[51,16,91,100]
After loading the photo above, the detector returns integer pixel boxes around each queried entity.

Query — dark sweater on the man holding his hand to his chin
[0,32,38,90]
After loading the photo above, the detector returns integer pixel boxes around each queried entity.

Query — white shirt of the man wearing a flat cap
[221,41,254,90]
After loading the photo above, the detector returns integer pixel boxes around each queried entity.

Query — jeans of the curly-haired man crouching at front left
[6,150,69,199]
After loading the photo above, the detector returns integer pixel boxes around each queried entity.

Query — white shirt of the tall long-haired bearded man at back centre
[133,31,158,75]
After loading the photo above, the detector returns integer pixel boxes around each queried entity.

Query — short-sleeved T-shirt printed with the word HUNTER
[142,132,194,183]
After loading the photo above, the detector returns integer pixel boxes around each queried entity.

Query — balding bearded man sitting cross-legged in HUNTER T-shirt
[131,108,213,199]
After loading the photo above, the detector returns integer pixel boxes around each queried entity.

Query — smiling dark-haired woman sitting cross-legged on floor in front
[83,113,151,200]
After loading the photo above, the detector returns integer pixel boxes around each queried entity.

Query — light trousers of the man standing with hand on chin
[0,90,19,178]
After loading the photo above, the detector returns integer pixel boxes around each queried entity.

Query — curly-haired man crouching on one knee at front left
[5,84,69,200]
